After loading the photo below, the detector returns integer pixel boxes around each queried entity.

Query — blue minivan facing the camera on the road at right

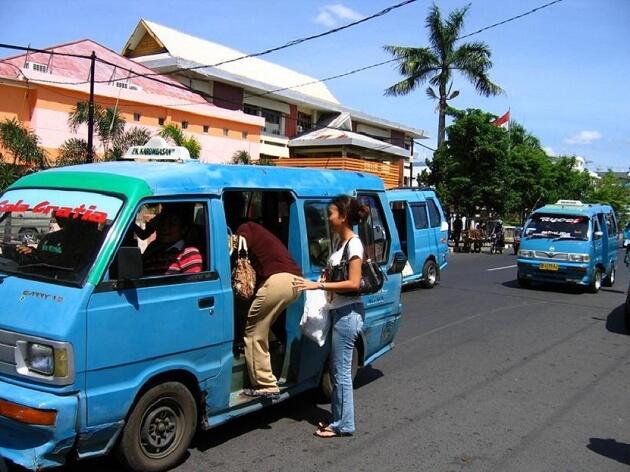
[517,200,618,293]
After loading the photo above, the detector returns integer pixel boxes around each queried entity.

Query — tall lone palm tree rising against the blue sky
[384,4,503,147]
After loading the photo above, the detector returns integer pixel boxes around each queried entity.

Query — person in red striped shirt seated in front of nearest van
[142,209,203,275]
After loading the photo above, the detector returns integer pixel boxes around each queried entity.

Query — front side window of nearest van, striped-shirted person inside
[109,201,210,279]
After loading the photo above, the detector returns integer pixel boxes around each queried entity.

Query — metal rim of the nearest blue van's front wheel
[140,399,184,459]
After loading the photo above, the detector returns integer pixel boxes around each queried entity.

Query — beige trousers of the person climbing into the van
[244,272,298,392]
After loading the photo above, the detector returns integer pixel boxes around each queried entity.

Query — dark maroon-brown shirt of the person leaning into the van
[236,221,302,282]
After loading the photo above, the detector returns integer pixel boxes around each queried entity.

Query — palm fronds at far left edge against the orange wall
[0,118,47,168]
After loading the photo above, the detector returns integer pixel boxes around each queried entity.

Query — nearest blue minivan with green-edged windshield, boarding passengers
[0,161,406,471]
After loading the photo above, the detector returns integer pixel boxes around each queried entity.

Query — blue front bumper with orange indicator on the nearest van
[0,380,79,470]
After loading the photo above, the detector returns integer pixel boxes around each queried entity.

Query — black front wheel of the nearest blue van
[116,382,197,472]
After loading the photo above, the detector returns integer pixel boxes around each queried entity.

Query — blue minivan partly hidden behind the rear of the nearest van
[387,187,448,288]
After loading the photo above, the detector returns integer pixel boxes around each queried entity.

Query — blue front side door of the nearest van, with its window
[86,199,233,426]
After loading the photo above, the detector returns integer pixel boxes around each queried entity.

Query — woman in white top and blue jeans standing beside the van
[296,195,369,438]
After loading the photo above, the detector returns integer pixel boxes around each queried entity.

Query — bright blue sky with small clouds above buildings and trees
[0,0,630,171]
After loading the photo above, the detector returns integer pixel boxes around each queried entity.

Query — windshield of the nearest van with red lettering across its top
[0,189,123,285]
